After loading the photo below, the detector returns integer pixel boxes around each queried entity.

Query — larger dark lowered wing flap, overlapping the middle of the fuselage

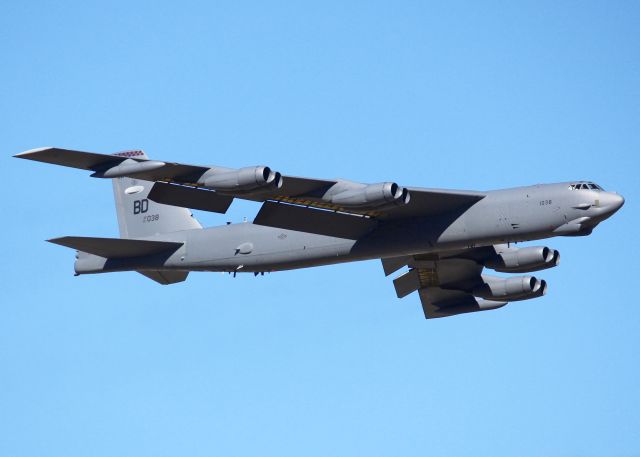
[253,202,377,240]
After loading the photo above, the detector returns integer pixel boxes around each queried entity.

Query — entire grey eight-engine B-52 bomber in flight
[15,148,624,318]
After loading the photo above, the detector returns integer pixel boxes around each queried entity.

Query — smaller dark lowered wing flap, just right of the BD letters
[149,182,233,214]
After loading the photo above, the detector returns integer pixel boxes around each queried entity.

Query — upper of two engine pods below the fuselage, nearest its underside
[484,246,560,273]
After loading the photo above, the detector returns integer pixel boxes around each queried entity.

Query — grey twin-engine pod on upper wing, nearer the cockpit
[323,182,411,210]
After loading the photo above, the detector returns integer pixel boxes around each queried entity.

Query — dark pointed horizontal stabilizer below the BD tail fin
[47,236,184,259]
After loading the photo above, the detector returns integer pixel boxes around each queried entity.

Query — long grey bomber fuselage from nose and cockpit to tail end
[75,182,624,274]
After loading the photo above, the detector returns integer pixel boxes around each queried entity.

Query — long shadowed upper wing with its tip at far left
[16,147,485,218]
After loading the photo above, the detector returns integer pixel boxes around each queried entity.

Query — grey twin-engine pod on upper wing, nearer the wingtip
[198,166,282,193]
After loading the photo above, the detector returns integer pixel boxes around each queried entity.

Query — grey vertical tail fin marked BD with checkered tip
[113,151,202,238]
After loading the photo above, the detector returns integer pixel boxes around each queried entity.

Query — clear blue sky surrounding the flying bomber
[0,1,640,457]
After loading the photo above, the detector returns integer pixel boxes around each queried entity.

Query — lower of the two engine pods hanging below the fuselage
[473,276,547,301]
